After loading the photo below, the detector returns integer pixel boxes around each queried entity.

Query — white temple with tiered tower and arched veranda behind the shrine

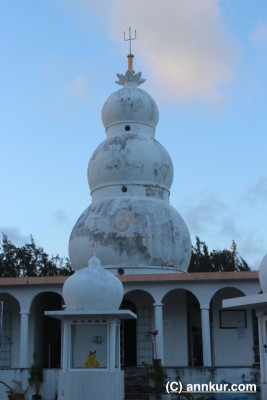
[0,50,261,400]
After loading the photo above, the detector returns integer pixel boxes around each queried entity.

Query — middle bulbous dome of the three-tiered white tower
[88,133,173,192]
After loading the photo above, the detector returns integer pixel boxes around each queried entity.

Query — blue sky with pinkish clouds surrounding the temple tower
[0,0,267,269]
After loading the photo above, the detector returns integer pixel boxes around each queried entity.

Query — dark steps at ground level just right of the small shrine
[124,367,149,400]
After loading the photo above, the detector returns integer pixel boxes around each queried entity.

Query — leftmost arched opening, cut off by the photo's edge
[0,293,20,368]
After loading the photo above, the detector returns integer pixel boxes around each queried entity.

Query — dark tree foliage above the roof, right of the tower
[188,237,250,272]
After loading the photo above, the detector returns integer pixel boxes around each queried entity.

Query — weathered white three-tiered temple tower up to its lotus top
[69,58,191,274]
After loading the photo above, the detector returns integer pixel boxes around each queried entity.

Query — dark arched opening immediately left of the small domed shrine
[31,292,63,368]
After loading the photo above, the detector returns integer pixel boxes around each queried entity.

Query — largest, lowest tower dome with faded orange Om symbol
[69,197,191,271]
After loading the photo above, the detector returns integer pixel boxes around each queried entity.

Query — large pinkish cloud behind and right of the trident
[68,0,239,102]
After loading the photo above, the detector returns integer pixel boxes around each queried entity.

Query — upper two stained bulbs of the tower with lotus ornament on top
[88,72,173,195]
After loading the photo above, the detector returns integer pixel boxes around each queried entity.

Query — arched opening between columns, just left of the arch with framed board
[162,289,203,366]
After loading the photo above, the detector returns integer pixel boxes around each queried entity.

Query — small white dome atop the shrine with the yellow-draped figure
[63,255,123,311]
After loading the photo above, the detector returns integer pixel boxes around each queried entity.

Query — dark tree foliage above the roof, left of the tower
[0,234,73,278]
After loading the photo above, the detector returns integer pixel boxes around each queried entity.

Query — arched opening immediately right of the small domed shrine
[121,290,154,367]
